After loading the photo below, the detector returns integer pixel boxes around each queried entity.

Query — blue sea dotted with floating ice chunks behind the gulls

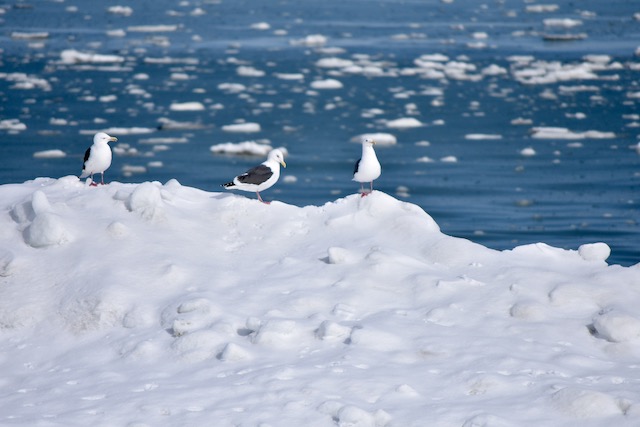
[0,0,640,265]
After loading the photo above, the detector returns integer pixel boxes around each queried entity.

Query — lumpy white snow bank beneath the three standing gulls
[0,176,640,427]
